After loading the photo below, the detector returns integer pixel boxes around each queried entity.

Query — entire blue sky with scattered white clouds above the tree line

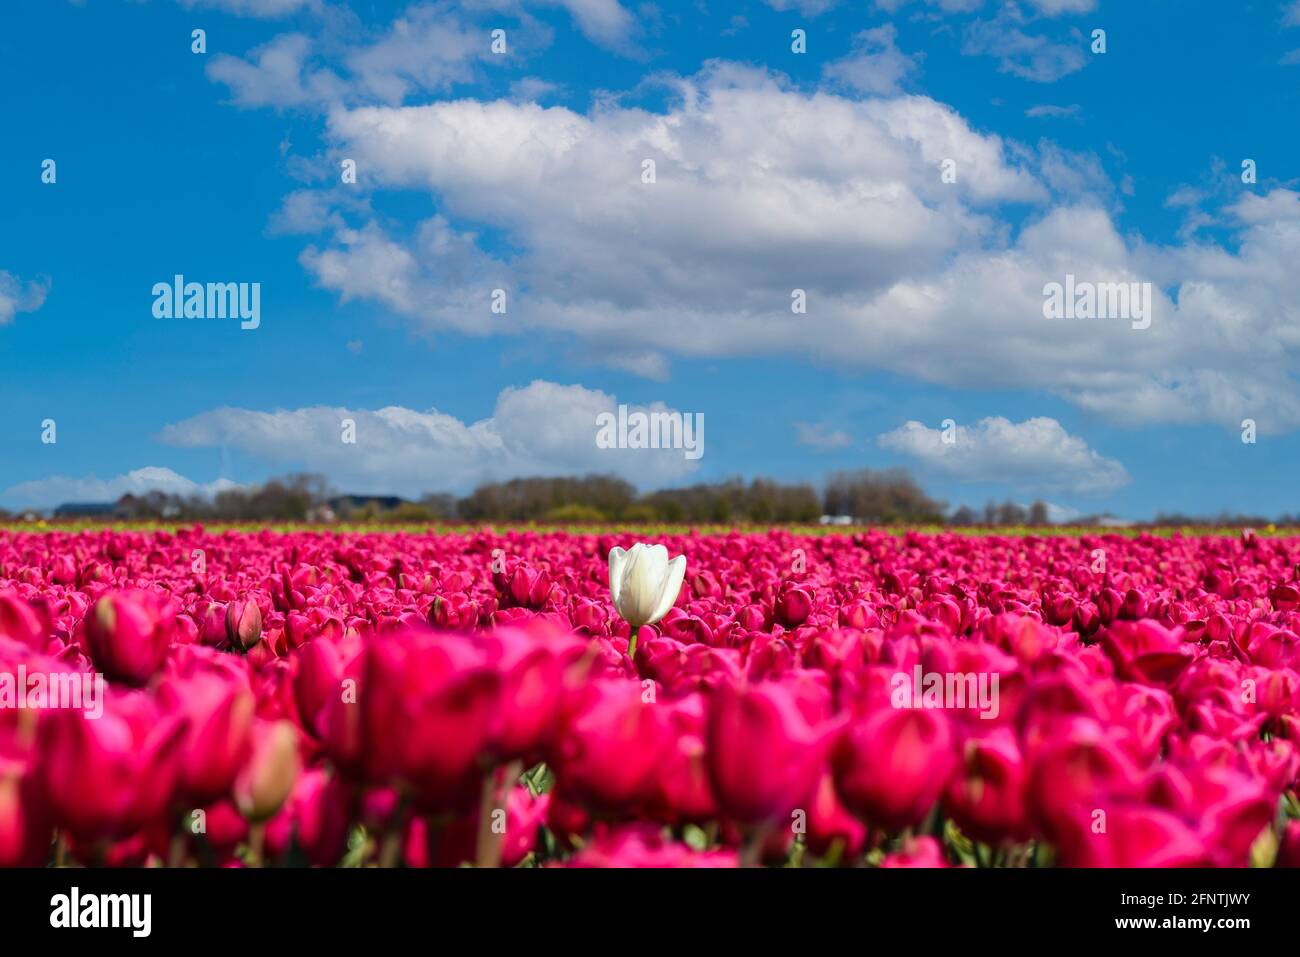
[0,0,1300,518]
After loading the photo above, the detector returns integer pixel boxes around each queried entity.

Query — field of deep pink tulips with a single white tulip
[0,528,1300,867]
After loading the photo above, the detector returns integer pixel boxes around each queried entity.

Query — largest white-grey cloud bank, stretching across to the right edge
[263,64,1300,433]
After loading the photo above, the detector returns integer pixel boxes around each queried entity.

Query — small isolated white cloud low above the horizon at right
[876,416,1128,493]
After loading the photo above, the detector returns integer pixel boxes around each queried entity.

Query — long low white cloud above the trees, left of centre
[160,380,707,495]
